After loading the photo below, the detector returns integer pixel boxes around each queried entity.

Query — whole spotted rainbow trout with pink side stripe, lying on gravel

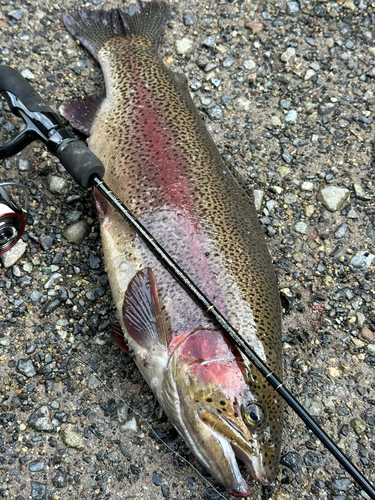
[61,1,283,497]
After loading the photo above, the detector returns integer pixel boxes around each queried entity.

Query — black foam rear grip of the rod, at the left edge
[0,66,53,113]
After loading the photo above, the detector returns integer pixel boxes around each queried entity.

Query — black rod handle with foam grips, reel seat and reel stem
[0,66,105,187]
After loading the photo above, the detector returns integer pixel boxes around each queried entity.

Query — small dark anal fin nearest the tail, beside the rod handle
[59,94,105,136]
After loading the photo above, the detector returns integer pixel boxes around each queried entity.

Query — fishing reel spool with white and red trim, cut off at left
[0,182,28,254]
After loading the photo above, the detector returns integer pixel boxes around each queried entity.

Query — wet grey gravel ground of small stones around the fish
[0,0,375,500]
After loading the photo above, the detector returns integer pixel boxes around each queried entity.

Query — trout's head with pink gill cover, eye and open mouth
[169,330,282,497]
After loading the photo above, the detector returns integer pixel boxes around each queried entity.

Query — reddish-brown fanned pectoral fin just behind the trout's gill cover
[122,267,167,349]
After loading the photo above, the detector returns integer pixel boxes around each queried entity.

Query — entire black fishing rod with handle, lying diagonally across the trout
[0,66,375,500]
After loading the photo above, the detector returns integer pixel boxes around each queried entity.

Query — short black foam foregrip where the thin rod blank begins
[57,140,104,187]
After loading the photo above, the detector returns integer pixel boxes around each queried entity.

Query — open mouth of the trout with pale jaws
[199,408,270,498]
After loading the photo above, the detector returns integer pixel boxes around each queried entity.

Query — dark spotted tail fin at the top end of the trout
[64,0,169,58]
